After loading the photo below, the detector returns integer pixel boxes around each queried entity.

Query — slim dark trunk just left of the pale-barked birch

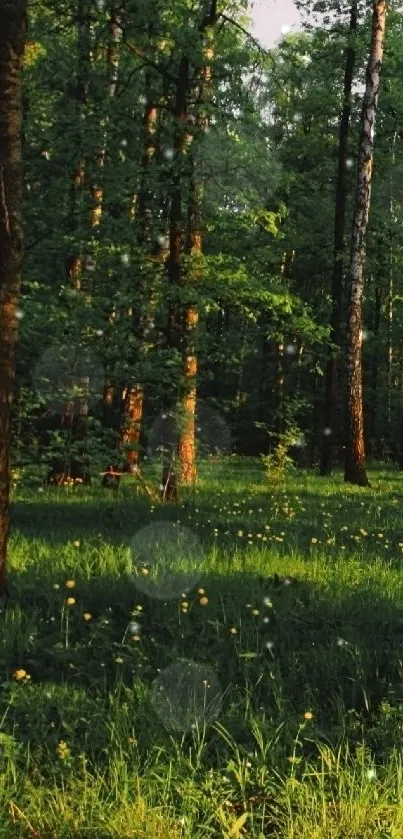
[320,0,357,475]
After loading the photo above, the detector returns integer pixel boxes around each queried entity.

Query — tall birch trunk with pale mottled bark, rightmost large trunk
[344,0,387,486]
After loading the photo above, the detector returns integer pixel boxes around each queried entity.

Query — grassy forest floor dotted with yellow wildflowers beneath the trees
[0,459,403,839]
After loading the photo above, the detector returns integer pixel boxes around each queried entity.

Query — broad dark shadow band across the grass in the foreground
[0,572,403,759]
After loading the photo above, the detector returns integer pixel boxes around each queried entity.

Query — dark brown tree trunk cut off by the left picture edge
[0,0,27,594]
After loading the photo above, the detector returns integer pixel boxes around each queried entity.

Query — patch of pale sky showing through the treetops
[250,0,300,47]
